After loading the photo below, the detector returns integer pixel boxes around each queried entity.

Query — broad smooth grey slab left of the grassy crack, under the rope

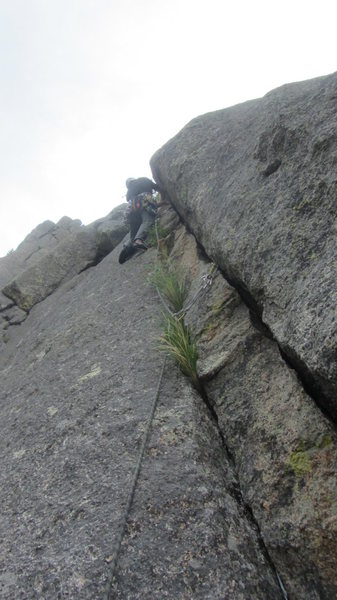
[0,238,282,600]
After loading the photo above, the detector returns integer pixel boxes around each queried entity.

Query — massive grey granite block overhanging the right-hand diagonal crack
[151,74,337,420]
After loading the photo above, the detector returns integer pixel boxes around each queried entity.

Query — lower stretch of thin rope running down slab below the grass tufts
[105,356,166,600]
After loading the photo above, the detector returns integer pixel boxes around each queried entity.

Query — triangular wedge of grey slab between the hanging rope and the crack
[113,366,282,599]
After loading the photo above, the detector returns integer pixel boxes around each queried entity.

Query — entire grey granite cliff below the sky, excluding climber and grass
[0,75,337,600]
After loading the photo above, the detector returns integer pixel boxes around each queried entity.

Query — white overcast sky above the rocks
[0,0,337,256]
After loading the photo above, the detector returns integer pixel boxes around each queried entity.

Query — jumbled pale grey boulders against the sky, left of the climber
[0,205,127,328]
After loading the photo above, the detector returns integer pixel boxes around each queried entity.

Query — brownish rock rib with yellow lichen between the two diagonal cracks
[158,204,337,600]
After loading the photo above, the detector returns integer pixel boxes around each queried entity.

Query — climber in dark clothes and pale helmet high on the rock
[119,177,160,263]
